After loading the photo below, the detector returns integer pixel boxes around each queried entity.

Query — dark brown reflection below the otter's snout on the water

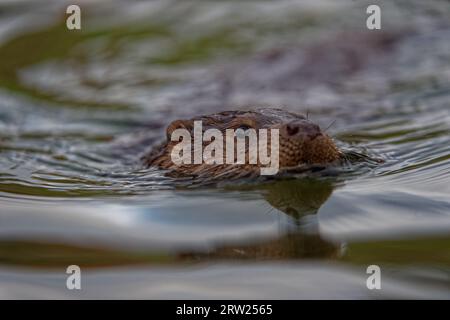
[181,178,339,260]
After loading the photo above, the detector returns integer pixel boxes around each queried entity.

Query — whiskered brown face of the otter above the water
[148,109,340,176]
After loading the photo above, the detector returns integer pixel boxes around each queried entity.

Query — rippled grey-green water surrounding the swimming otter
[0,1,450,299]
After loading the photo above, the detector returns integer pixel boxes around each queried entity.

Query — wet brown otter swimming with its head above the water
[143,108,342,180]
